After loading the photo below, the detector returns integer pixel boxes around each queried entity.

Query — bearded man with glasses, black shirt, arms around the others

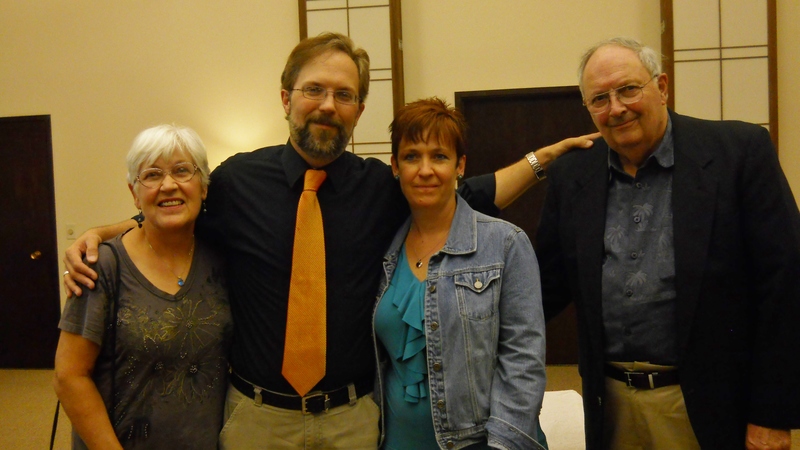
[65,33,591,449]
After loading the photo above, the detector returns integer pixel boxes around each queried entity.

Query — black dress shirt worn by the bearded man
[198,143,497,394]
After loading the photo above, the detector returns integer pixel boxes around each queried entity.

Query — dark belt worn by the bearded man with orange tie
[230,372,374,413]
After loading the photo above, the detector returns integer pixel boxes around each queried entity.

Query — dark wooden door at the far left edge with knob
[0,116,61,368]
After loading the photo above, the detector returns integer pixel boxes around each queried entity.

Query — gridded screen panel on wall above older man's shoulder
[662,0,778,148]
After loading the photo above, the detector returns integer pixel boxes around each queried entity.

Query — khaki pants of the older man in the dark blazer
[603,362,700,450]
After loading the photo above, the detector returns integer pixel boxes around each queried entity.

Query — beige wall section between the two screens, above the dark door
[403,0,661,104]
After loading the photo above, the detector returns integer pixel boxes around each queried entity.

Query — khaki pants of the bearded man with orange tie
[219,385,380,450]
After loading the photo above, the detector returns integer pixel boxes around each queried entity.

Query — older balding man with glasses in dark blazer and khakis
[537,38,800,450]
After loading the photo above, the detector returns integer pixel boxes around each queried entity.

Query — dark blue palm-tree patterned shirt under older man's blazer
[603,118,678,365]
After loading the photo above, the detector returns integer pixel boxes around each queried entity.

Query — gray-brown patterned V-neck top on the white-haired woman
[59,235,233,450]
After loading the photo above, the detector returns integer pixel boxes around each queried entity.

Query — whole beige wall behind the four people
[0,0,800,306]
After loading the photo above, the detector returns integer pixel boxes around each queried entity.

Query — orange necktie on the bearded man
[281,169,327,396]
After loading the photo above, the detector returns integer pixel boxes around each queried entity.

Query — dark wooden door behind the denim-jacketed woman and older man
[456,86,596,364]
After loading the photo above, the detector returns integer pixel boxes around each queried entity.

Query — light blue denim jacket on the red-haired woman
[373,195,546,449]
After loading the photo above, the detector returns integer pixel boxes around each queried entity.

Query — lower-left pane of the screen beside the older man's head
[673,61,722,120]
